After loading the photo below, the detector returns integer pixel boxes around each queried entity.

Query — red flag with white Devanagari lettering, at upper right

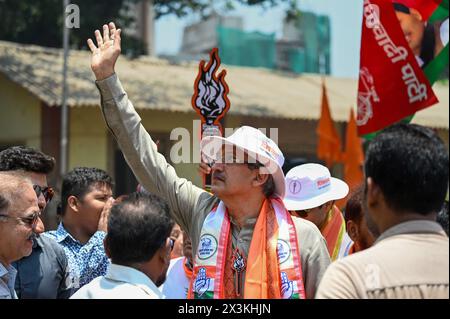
[356,0,438,135]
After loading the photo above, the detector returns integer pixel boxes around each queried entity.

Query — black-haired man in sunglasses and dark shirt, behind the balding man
[0,146,72,299]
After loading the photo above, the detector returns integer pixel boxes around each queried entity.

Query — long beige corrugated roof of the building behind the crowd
[0,41,449,129]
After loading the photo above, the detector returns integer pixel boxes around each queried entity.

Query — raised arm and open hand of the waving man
[88,22,209,232]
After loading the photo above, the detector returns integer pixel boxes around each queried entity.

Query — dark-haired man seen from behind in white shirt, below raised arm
[71,193,175,299]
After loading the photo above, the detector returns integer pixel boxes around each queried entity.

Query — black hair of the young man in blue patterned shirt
[57,167,114,216]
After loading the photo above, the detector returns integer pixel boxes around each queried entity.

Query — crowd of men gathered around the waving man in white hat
[0,23,449,299]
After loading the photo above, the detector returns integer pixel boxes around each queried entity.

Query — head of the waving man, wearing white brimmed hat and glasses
[201,126,285,202]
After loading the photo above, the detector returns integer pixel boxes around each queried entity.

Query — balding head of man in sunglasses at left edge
[0,172,40,266]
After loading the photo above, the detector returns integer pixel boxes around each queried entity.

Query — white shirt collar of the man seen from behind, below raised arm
[105,264,163,298]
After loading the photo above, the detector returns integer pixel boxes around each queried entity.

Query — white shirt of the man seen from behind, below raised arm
[70,264,163,299]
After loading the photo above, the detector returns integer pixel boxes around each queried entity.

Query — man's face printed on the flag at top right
[395,9,425,56]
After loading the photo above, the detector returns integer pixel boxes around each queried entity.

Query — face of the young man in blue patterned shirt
[78,183,112,235]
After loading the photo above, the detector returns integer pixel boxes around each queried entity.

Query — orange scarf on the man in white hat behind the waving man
[322,205,345,261]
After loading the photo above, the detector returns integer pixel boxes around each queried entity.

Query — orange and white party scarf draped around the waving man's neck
[189,198,305,299]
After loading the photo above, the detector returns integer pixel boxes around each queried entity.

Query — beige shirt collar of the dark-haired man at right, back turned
[375,220,445,243]
